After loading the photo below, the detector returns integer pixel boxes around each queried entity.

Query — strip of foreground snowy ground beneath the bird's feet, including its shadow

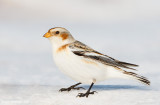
[0,85,160,105]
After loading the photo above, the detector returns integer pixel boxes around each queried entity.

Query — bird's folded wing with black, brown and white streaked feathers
[69,41,138,70]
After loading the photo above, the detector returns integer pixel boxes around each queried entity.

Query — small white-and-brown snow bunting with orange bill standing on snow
[43,27,150,97]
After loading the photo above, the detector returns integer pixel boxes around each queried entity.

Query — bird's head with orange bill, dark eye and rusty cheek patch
[43,27,75,47]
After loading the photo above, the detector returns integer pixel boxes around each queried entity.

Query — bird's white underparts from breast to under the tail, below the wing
[53,48,124,84]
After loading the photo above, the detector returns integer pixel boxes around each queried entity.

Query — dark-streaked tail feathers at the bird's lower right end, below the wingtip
[124,71,150,85]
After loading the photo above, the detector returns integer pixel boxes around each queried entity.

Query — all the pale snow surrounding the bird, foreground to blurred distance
[0,0,160,105]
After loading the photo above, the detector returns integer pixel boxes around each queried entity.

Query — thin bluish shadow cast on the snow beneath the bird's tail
[82,85,150,91]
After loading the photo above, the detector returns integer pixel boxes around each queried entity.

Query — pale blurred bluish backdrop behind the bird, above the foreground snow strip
[0,0,160,89]
